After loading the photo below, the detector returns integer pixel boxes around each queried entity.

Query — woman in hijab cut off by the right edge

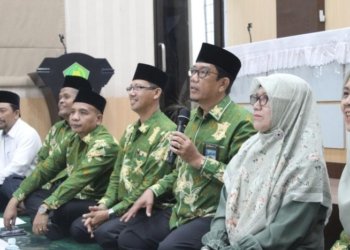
[332,72,350,250]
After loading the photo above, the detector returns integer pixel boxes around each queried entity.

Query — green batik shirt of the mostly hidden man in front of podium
[36,120,74,189]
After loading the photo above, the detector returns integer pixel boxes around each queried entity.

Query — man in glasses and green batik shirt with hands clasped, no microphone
[71,63,176,249]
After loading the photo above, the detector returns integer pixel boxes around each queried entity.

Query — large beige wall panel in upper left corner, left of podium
[0,0,65,76]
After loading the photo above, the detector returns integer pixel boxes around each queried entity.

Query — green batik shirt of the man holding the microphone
[151,96,256,229]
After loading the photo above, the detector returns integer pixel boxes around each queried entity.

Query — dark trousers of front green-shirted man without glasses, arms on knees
[25,188,96,238]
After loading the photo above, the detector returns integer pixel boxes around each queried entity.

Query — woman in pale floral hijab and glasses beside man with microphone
[202,74,332,250]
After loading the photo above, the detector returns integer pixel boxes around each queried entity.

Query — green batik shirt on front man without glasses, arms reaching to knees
[13,125,119,209]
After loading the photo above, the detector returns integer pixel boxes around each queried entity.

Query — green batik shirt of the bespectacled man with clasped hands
[99,111,176,216]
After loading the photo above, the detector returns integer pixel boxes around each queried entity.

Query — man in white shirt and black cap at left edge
[0,90,41,211]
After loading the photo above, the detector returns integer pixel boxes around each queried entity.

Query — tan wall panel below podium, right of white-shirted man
[21,97,51,140]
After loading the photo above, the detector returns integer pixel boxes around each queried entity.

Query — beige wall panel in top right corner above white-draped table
[325,0,350,30]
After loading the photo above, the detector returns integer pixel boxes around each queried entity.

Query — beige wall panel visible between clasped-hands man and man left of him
[103,97,138,140]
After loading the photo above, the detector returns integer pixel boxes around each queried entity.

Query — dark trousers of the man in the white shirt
[0,174,25,212]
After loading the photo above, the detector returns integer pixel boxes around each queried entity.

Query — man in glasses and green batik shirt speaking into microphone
[119,43,255,250]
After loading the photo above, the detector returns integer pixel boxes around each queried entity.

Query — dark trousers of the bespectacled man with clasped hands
[70,210,152,250]
